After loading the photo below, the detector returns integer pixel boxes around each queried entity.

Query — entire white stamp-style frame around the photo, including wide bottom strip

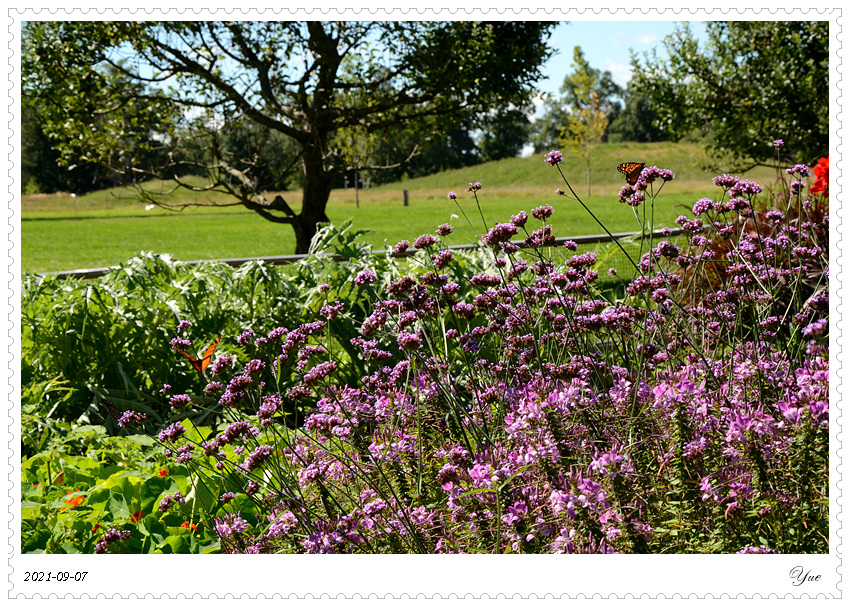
[0,1,845,600]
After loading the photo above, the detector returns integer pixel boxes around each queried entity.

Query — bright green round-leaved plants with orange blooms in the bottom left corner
[21,423,237,554]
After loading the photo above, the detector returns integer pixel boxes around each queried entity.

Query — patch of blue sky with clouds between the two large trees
[538,21,705,95]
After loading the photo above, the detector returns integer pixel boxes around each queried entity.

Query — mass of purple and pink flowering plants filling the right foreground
[141,145,829,553]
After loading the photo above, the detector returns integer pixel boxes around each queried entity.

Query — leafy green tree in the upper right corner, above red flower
[630,21,829,169]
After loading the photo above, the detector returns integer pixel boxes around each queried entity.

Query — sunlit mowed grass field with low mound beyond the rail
[21,143,776,272]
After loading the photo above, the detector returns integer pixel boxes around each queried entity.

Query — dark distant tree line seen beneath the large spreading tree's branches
[21,83,533,194]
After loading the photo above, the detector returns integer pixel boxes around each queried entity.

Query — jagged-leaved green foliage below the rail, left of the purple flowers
[21,222,496,446]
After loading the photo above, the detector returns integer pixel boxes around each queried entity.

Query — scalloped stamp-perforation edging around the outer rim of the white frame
[4,3,844,600]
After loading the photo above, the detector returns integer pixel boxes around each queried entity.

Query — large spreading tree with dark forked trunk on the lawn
[23,21,553,252]
